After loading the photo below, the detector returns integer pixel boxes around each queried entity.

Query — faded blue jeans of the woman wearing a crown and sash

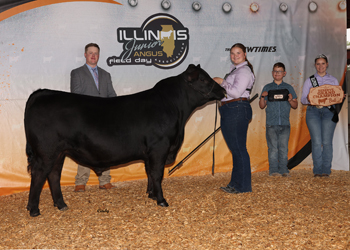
[306,106,336,174]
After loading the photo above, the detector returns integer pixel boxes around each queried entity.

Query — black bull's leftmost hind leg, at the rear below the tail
[27,160,47,217]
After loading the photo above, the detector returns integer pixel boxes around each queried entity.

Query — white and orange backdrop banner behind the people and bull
[0,0,349,195]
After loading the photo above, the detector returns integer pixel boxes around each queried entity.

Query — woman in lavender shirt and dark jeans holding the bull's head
[213,43,255,194]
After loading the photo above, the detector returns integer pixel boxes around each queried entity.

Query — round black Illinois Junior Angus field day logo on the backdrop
[107,13,190,69]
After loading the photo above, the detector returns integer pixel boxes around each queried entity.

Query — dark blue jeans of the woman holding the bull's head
[219,101,252,192]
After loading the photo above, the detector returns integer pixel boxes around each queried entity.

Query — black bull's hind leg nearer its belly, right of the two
[47,156,68,211]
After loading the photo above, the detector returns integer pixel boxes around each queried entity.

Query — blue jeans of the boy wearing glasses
[266,125,290,174]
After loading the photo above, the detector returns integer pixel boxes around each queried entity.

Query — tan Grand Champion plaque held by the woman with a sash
[309,84,344,106]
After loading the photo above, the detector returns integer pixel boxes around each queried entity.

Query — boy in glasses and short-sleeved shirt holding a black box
[259,62,298,177]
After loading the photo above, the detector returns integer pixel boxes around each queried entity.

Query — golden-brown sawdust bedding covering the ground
[0,170,350,249]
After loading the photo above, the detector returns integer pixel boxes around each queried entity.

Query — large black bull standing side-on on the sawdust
[24,64,225,216]
